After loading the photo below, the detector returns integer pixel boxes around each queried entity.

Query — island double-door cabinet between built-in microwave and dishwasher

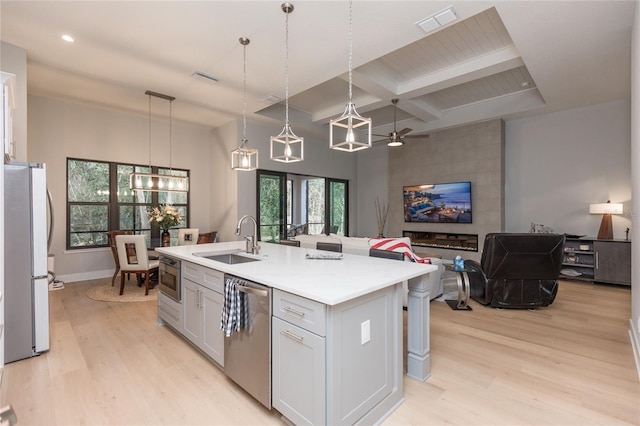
[182,262,224,366]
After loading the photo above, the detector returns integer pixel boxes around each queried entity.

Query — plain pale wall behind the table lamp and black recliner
[505,100,631,238]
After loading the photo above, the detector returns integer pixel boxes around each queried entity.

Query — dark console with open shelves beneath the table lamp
[560,237,631,285]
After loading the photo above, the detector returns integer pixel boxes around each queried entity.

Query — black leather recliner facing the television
[465,233,565,309]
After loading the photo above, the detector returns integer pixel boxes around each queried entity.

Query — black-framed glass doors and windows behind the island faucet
[257,170,349,242]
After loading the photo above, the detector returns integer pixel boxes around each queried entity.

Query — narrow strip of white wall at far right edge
[629,2,640,377]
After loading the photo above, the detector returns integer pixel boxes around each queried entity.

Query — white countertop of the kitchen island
[155,241,437,305]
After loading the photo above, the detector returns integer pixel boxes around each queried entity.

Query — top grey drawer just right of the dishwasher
[273,289,327,336]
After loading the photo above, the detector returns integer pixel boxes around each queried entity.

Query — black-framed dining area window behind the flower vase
[67,158,189,249]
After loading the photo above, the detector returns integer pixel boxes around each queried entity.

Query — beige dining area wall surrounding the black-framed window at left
[28,93,211,281]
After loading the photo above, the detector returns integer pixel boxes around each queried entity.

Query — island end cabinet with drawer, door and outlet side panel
[272,284,403,425]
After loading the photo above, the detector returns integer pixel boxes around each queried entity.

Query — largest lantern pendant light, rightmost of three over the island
[329,0,371,152]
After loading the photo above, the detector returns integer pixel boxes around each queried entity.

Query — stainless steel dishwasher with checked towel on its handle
[224,275,271,409]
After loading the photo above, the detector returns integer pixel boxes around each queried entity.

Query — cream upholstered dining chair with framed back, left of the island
[116,235,160,296]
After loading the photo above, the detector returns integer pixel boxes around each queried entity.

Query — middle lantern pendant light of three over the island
[271,3,304,163]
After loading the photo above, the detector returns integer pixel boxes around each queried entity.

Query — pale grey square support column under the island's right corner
[407,274,431,382]
